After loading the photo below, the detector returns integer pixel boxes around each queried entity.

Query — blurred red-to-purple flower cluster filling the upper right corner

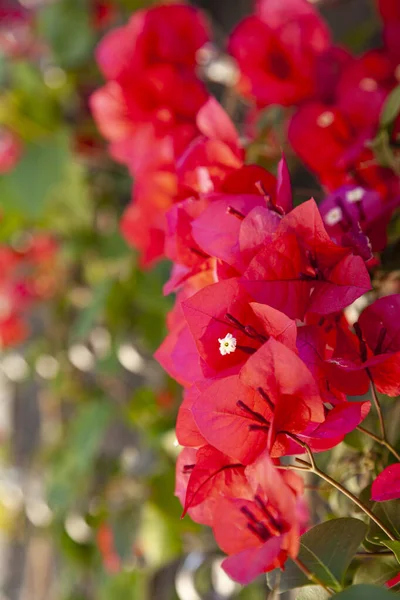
[229,0,400,251]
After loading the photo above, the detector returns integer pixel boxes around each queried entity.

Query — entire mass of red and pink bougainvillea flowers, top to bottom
[92,0,400,583]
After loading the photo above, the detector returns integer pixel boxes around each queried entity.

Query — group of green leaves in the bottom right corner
[268,516,400,600]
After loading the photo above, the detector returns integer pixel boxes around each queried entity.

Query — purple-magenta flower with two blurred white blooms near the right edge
[319,185,400,252]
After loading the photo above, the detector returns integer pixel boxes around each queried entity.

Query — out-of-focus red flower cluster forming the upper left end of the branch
[91,4,209,264]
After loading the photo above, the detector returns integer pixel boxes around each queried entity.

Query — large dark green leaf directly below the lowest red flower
[268,518,367,592]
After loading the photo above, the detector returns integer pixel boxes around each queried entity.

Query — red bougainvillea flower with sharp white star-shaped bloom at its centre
[182,279,296,376]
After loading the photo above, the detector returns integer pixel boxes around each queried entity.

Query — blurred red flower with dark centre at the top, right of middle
[228,0,330,106]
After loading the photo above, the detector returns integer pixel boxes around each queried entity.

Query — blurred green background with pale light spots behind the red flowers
[0,0,379,600]
